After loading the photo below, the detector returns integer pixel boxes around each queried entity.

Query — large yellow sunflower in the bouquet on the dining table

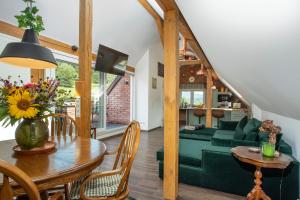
[8,91,39,119]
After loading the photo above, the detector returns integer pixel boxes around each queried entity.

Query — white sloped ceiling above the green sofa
[176,0,300,120]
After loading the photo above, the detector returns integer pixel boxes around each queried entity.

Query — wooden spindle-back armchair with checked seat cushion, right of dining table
[71,121,140,200]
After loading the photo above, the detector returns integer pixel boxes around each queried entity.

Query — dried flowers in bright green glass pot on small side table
[259,120,281,157]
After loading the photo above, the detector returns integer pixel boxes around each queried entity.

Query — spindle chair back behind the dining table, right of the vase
[45,114,77,136]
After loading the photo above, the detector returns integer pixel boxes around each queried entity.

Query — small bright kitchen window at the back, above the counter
[180,90,204,106]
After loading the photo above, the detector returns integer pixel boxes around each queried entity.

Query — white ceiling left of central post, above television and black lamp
[0,0,159,66]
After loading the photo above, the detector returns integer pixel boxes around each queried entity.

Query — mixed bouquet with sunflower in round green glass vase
[0,77,68,149]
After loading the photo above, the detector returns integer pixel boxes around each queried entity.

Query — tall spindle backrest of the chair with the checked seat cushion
[113,121,140,196]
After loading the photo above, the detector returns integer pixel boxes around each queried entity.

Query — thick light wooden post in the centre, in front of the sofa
[164,10,179,200]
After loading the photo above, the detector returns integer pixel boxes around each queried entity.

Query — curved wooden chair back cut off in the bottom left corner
[0,160,41,200]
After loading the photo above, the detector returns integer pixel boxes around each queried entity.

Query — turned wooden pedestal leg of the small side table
[247,167,271,200]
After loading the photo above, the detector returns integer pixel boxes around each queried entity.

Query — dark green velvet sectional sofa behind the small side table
[157,119,299,200]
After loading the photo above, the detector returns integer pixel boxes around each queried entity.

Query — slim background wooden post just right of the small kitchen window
[205,69,213,128]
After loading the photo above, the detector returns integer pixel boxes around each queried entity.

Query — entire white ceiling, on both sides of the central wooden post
[0,0,300,119]
